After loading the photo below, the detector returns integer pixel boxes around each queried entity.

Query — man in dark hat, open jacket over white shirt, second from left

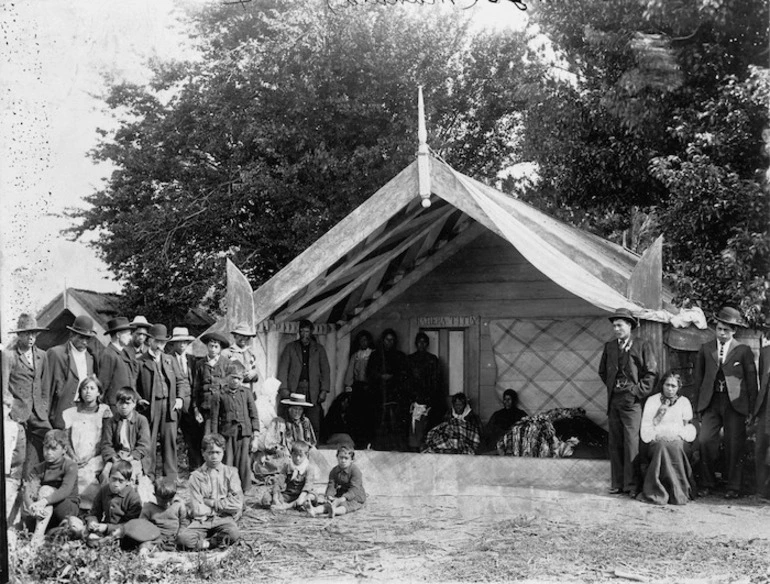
[43,315,96,430]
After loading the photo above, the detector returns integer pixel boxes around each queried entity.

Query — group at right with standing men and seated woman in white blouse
[599,307,770,505]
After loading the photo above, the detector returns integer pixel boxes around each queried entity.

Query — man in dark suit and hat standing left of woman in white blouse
[599,308,658,497]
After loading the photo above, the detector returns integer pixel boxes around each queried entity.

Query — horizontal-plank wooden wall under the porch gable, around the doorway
[351,232,606,422]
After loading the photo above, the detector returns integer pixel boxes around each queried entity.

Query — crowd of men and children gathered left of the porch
[1,315,366,550]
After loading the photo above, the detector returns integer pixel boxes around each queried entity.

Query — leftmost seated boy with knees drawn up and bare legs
[24,430,79,545]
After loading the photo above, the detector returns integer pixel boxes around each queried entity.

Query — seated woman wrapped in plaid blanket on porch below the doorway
[422,393,481,454]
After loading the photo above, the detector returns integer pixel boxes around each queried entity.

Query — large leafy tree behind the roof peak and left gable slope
[76,0,531,320]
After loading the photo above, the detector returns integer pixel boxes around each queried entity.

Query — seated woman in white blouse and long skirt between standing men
[641,373,696,505]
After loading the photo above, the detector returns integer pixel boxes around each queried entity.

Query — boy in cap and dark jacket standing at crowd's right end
[206,361,259,492]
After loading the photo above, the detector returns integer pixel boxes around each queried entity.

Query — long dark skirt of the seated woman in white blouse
[642,440,696,505]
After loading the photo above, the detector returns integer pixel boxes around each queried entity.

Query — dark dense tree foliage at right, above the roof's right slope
[523,0,770,322]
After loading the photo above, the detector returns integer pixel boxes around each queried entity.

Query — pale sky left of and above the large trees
[0,0,526,341]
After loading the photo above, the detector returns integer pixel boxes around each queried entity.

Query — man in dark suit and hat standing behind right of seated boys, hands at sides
[136,324,190,480]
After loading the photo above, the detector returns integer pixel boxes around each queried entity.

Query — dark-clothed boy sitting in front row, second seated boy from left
[86,460,142,545]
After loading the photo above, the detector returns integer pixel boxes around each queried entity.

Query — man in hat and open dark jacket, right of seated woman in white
[693,306,757,499]
